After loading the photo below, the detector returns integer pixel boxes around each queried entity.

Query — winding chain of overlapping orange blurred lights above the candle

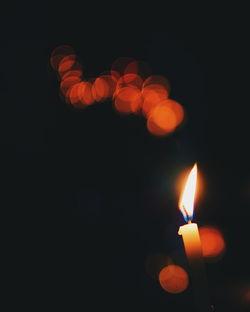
[50,45,184,136]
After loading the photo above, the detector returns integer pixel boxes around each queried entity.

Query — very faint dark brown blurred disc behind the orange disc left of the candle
[145,253,172,280]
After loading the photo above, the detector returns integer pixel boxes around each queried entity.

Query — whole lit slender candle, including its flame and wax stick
[178,164,211,312]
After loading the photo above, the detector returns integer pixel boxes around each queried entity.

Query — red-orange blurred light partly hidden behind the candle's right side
[199,226,225,259]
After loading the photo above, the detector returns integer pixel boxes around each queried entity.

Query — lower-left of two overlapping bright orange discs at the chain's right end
[147,105,177,135]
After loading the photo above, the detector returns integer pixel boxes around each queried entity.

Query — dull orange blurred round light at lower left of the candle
[159,264,189,294]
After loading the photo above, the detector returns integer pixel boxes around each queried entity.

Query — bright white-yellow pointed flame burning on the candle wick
[179,163,197,222]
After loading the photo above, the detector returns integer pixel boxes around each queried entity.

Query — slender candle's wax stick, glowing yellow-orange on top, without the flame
[178,223,211,312]
